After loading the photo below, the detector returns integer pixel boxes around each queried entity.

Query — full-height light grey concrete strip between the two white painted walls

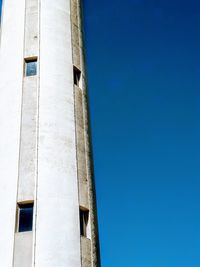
[13,0,39,267]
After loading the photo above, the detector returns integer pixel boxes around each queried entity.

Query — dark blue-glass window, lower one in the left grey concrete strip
[17,202,33,232]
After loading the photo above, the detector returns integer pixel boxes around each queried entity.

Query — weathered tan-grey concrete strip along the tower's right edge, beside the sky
[71,0,100,267]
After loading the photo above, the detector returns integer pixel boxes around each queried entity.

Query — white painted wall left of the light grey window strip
[0,0,25,267]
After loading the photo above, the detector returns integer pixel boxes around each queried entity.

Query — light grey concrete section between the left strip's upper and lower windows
[17,76,37,202]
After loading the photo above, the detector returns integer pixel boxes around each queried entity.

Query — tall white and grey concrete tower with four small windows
[0,0,100,267]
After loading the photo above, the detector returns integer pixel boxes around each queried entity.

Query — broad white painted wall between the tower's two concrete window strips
[35,0,81,267]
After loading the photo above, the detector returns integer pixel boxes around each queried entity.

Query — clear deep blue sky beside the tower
[1,0,200,267]
